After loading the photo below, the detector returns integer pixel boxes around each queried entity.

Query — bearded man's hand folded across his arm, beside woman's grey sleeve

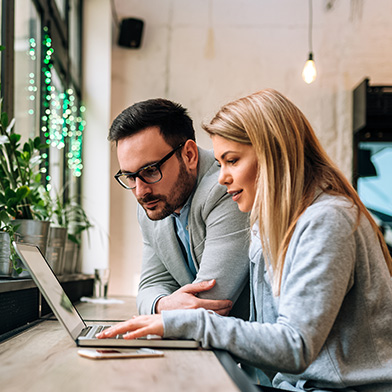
[155,279,233,316]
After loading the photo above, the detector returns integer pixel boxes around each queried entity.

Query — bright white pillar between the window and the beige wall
[82,0,112,273]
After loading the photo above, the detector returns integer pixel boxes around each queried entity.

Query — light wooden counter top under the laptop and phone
[0,298,253,392]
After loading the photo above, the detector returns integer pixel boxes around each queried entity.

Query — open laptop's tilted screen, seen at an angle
[14,243,85,340]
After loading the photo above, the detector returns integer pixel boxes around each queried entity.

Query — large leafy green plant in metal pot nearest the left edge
[0,47,49,276]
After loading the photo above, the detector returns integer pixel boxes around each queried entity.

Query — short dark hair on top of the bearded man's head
[108,98,195,148]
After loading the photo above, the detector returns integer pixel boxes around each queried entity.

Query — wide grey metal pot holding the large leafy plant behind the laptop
[11,219,50,278]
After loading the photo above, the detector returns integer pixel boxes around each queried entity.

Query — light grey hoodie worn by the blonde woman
[163,194,392,392]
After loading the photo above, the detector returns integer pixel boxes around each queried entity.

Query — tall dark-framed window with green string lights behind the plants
[1,0,85,198]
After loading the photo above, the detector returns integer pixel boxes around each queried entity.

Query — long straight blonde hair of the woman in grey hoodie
[203,89,392,294]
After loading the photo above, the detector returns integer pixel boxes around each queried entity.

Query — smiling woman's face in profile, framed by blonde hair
[212,135,257,212]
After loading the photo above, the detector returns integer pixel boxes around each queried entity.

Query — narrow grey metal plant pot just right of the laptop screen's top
[46,226,67,275]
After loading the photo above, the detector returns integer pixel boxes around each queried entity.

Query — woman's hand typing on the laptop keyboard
[97,314,163,339]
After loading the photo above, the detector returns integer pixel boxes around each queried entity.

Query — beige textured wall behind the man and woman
[104,0,392,294]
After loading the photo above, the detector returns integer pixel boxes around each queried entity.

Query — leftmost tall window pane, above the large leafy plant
[14,0,41,140]
